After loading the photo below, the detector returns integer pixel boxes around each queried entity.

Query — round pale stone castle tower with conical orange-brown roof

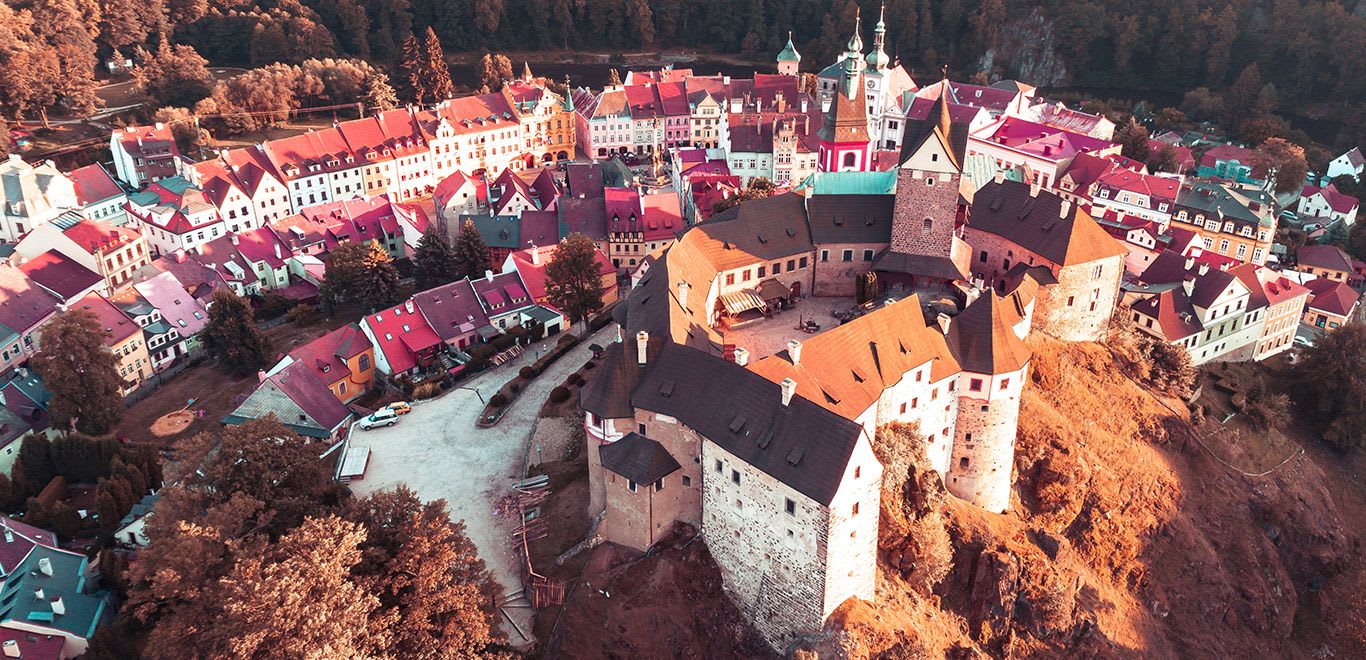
[944,292,1030,514]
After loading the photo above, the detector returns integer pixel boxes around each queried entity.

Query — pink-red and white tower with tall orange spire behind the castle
[818,14,873,172]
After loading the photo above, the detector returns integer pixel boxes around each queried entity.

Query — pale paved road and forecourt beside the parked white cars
[351,329,611,644]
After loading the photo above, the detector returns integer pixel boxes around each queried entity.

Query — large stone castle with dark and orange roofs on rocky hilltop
[581,10,1126,648]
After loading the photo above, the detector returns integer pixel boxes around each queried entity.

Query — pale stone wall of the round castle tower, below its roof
[945,363,1029,514]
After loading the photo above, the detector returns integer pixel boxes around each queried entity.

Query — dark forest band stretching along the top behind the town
[0,0,1366,143]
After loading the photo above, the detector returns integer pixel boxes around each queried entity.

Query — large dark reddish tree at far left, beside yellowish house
[33,309,124,436]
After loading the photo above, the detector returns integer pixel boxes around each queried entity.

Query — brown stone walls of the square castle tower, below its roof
[892,169,959,257]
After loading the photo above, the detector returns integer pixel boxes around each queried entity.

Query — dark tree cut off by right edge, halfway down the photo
[1291,324,1366,452]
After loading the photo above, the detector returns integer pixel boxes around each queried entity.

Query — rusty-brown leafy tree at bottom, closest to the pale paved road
[347,485,500,657]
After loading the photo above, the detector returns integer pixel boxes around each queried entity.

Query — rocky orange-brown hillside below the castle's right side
[807,338,1366,657]
